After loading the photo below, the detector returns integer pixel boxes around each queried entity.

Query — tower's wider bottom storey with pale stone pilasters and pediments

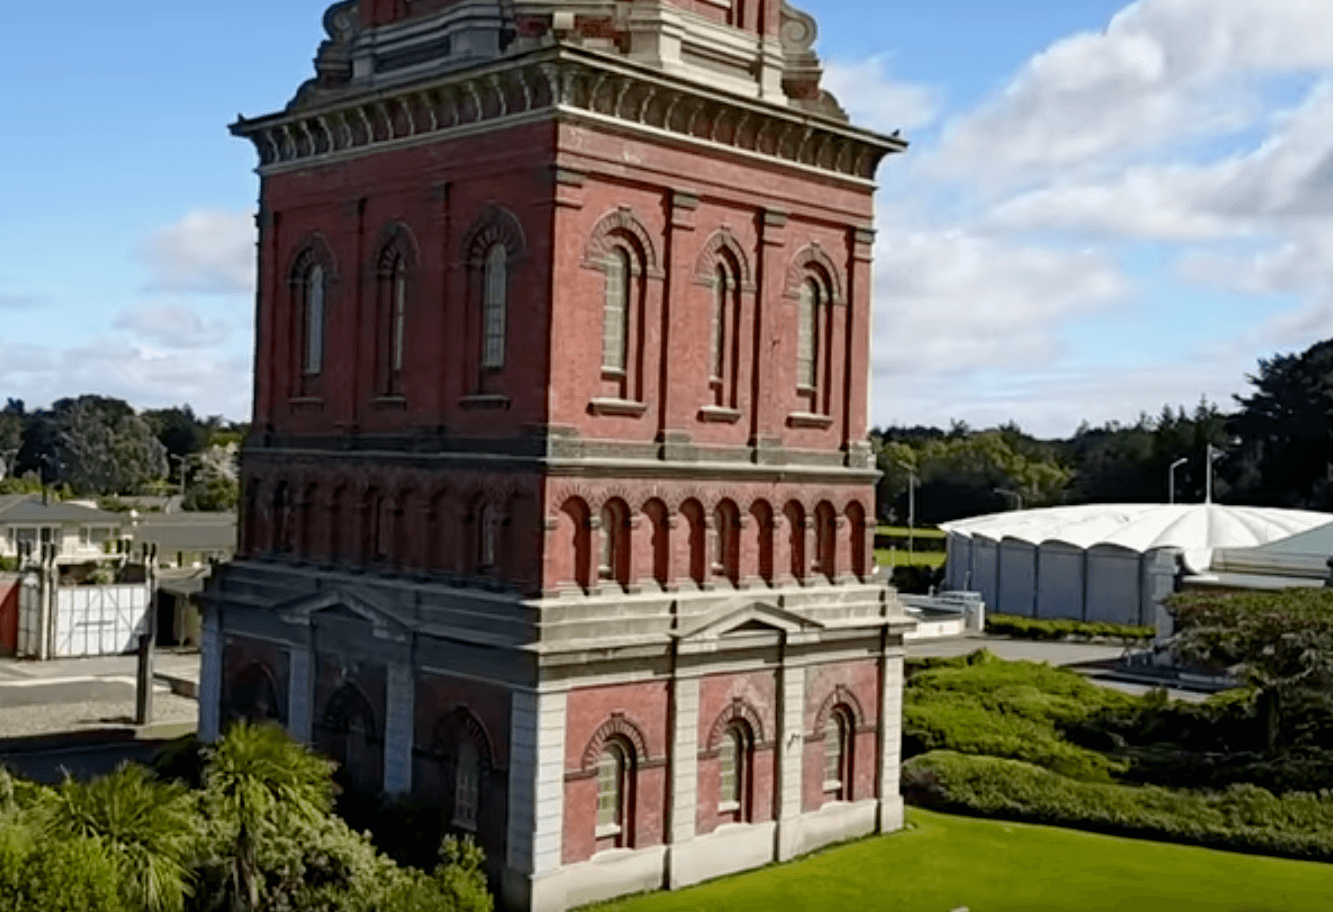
[200,561,912,911]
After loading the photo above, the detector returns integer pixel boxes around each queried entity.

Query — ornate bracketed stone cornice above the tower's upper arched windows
[231,45,906,183]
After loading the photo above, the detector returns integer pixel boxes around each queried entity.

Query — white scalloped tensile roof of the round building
[940,504,1333,573]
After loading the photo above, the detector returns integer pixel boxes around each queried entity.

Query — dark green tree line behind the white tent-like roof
[870,334,1333,524]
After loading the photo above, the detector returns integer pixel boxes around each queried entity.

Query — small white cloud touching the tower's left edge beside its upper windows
[139,209,255,295]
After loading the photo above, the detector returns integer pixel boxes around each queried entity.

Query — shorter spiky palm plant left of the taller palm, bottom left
[33,763,200,912]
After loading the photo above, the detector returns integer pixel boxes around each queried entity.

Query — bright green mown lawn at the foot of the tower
[597,808,1333,912]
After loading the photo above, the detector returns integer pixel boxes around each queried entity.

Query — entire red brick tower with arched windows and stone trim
[200,0,910,909]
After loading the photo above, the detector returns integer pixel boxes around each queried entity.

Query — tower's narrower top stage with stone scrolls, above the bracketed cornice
[288,0,846,120]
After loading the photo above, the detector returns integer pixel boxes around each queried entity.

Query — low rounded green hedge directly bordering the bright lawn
[902,751,1333,861]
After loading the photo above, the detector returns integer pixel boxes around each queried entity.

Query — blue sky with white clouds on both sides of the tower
[0,0,1333,435]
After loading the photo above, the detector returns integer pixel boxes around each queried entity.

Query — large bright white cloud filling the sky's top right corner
[929,0,1333,187]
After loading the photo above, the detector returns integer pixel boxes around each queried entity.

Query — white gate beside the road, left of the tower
[52,584,149,657]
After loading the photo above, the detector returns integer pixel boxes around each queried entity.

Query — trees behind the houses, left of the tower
[0,395,248,509]
